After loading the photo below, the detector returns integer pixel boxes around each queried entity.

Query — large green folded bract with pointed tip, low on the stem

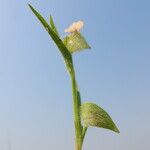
[80,102,119,133]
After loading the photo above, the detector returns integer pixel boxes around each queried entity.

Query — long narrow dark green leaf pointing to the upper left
[28,4,73,73]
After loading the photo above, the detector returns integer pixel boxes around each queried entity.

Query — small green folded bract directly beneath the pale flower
[64,31,91,53]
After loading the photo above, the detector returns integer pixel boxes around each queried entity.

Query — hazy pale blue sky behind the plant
[0,0,150,150]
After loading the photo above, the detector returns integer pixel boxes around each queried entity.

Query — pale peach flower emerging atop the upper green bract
[65,21,84,33]
